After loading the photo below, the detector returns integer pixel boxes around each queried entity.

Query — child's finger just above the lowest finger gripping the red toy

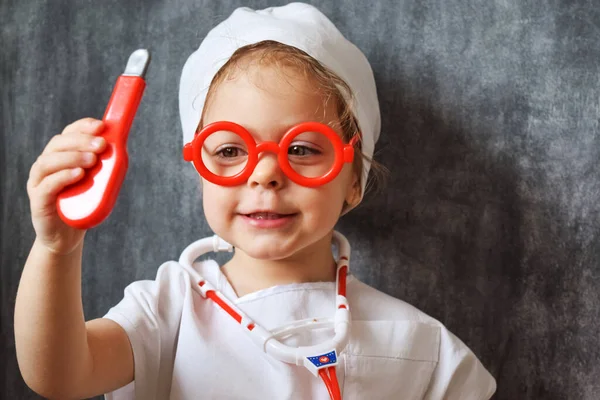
[27,151,98,188]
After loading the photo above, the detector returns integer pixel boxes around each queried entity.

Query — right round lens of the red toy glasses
[287,132,335,178]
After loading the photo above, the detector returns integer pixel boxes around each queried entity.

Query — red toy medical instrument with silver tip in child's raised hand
[56,49,150,229]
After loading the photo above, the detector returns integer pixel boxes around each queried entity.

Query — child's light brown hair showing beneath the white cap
[199,40,385,198]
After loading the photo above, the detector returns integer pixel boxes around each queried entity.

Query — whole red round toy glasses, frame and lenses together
[183,121,360,187]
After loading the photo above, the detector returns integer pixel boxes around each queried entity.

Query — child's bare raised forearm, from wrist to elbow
[15,241,92,397]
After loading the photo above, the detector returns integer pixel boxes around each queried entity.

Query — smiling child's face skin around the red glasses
[202,66,360,261]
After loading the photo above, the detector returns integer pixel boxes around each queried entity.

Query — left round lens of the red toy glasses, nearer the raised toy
[202,131,248,177]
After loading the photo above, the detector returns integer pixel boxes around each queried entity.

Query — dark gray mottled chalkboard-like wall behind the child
[0,0,600,400]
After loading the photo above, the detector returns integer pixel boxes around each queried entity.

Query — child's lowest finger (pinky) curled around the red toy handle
[30,168,84,215]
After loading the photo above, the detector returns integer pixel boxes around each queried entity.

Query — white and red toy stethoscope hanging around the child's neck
[179,231,351,400]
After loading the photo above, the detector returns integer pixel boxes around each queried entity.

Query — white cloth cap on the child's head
[179,3,381,197]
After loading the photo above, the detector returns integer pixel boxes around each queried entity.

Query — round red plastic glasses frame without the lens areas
[183,121,360,187]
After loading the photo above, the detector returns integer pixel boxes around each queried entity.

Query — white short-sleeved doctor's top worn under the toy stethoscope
[105,260,496,400]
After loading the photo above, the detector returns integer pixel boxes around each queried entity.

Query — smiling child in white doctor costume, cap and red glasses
[15,3,495,400]
